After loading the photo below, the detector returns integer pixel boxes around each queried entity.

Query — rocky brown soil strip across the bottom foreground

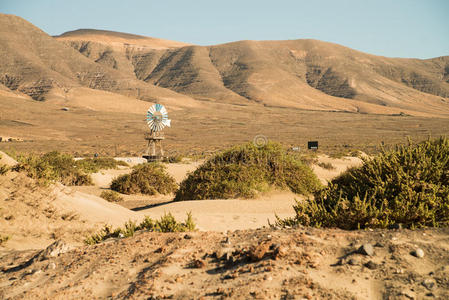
[0,228,449,299]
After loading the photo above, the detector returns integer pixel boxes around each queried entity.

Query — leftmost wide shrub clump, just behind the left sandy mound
[13,151,92,185]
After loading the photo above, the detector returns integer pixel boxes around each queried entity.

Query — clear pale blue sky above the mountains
[0,0,449,58]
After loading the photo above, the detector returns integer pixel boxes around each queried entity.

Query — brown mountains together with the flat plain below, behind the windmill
[0,14,449,155]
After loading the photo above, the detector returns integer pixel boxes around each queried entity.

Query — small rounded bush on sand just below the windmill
[111,163,178,195]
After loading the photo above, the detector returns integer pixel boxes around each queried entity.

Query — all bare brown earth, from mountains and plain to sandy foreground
[0,14,449,299]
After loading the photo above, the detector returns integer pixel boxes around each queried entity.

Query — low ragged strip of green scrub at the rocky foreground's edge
[84,213,196,245]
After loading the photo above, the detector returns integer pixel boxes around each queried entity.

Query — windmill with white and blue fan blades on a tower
[143,103,170,161]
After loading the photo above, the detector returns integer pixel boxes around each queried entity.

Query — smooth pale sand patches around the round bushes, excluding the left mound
[68,155,361,232]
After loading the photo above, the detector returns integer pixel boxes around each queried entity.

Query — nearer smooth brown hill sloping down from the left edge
[0,14,192,101]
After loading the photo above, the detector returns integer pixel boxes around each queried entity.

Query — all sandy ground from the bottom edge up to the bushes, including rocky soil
[0,156,449,299]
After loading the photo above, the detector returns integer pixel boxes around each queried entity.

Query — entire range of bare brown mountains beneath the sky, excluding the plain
[0,15,449,116]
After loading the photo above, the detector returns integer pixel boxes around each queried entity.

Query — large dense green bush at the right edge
[277,138,449,229]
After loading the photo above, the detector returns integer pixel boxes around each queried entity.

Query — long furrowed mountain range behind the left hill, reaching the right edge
[56,25,449,113]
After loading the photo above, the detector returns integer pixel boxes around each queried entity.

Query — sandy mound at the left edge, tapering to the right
[0,172,141,249]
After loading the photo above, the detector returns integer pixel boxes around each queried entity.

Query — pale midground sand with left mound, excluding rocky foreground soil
[0,154,360,250]
